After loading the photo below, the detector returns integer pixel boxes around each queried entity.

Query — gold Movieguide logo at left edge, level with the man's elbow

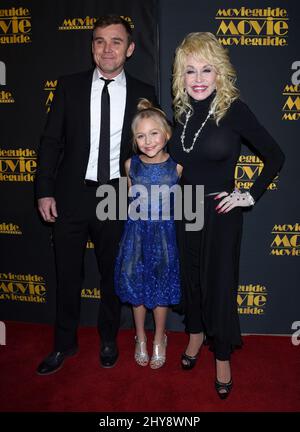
[0,148,37,182]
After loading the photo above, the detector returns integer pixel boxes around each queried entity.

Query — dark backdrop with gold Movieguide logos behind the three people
[0,0,300,334]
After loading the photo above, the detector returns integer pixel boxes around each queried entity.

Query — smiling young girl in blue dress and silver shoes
[115,99,182,369]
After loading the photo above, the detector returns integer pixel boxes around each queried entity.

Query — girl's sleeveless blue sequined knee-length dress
[115,155,181,309]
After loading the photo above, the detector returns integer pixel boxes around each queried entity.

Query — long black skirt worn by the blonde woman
[176,181,243,360]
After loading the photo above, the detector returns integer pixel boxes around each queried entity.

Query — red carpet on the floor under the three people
[0,322,300,412]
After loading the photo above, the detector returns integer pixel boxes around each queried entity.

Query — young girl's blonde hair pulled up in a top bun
[131,99,172,151]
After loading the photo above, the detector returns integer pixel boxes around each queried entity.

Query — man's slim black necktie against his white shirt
[98,78,113,184]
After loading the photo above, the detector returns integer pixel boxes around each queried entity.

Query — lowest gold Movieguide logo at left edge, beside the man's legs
[0,273,47,303]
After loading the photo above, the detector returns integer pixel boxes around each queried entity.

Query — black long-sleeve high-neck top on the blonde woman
[169,94,284,201]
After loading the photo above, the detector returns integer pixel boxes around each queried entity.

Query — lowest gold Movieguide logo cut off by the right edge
[270,223,300,256]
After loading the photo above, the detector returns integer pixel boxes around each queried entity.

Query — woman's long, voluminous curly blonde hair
[173,32,239,124]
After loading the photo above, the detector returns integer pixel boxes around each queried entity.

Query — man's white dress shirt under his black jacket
[85,67,126,181]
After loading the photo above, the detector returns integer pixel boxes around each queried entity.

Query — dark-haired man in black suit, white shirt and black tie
[36,15,155,375]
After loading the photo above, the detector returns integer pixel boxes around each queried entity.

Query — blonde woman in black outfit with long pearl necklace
[169,32,284,399]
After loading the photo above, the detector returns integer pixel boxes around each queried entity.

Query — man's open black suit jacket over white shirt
[35,70,156,211]
